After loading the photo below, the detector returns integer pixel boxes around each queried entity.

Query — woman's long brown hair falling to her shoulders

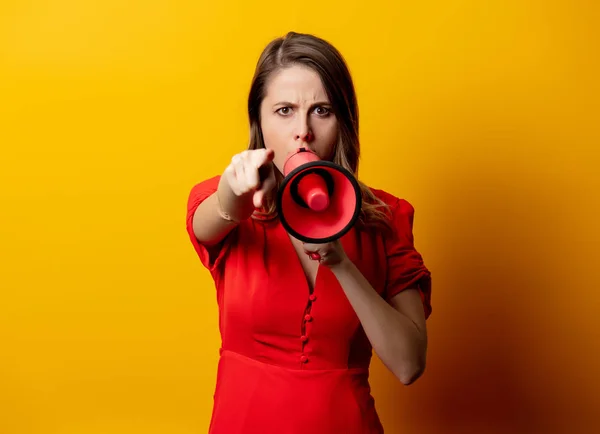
[248,32,389,232]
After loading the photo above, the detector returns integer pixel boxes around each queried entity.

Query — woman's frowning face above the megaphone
[260,66,338,173]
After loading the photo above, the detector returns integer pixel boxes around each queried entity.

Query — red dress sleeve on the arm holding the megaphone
[385,199,432,318]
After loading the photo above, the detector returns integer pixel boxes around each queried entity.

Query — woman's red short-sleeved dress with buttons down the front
[187,177,431,434]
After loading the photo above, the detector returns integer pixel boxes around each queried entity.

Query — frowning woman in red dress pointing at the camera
[187,33,431,434]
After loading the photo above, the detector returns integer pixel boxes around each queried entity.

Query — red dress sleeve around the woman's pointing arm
[186,176,231,273]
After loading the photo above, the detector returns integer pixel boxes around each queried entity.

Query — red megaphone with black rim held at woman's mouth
[276,148,362,259]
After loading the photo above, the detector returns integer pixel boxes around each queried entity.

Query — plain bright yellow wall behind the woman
[0,0,600,434]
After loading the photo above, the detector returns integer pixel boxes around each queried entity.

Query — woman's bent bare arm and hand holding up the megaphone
[305,242,427,385]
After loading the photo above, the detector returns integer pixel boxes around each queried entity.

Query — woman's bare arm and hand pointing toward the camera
[193,149,275,246]
